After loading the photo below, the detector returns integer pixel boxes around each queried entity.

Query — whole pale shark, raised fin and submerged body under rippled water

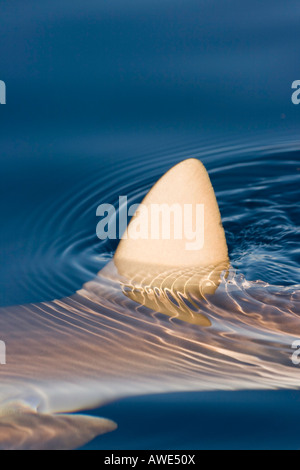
[0,159,300,449]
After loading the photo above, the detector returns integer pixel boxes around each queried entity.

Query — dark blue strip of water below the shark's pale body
[83,391,300,450]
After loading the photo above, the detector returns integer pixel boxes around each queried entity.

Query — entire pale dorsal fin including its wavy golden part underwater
[114,159,229,326]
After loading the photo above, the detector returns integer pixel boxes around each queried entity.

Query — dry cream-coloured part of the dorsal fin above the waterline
[115,159,228,271]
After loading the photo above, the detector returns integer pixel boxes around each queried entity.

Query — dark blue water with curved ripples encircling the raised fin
[8,137,300,301]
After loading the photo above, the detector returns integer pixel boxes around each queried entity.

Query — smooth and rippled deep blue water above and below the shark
[0,0,300,448]
